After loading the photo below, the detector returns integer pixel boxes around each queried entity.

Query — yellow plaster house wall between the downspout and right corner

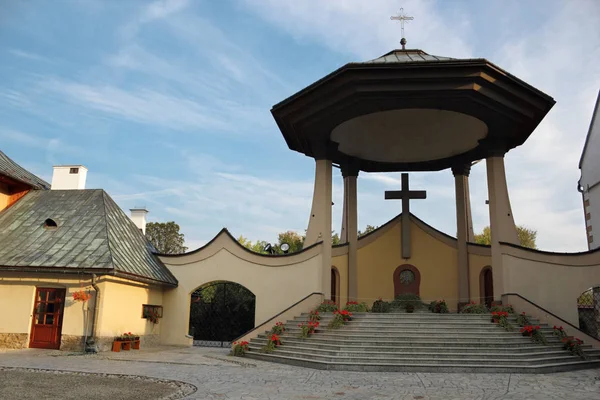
[96,277,163,336]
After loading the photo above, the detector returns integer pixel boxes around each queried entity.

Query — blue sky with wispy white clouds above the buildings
[0,0,600,252]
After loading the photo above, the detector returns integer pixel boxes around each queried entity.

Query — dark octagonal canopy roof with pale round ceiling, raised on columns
[271,50,555,172]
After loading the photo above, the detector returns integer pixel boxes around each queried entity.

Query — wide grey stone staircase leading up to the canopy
[247,312,600,373]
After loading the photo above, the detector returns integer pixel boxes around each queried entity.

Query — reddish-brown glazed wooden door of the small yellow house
[29,288,65,349]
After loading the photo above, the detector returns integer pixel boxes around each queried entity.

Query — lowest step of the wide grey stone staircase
[247,352,600,373]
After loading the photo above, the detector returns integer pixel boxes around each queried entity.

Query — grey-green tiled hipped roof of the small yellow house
[0,189,177,285]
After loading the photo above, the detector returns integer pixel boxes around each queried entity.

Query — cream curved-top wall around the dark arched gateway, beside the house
[161,233,321,345]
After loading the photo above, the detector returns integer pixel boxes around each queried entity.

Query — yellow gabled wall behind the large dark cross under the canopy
[358,221,458,308]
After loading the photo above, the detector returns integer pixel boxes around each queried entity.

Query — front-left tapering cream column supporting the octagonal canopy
[304,159,332,299]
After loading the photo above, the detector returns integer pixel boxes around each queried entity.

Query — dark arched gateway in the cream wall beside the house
[189,281,256,347]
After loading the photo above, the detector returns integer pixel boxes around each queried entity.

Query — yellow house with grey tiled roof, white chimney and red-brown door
[0,152,178,350]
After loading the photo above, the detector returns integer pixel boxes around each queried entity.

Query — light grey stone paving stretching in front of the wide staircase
[0,347,600,400]
